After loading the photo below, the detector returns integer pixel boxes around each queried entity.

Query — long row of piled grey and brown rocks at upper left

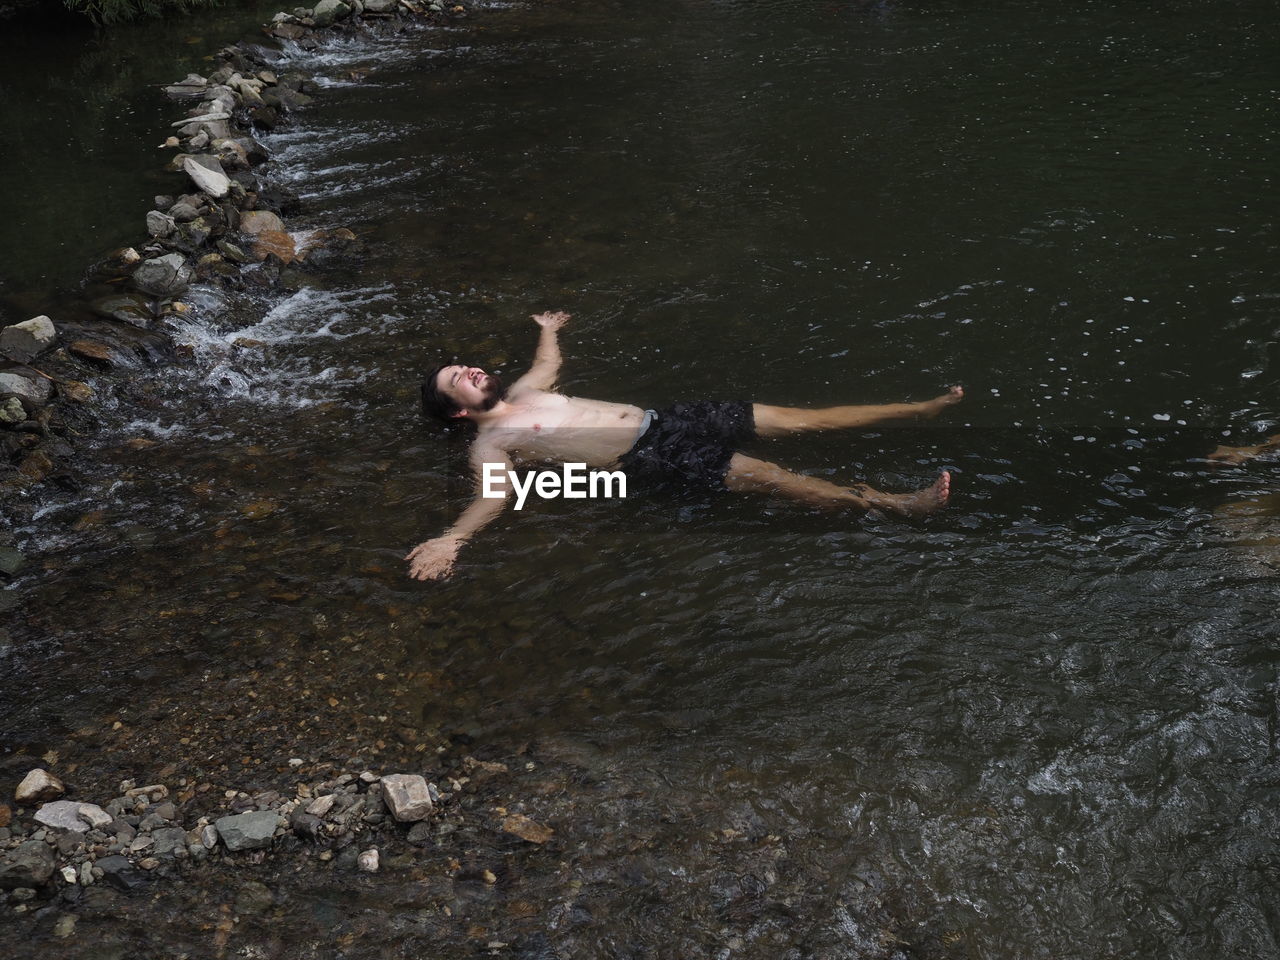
[0,0,466,582]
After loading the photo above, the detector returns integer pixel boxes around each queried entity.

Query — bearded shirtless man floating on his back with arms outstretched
[404,312,964,580]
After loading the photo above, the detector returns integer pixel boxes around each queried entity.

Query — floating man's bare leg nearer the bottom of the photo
[724,453,951,517]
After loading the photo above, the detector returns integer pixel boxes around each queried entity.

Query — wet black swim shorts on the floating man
[618,401,755,494]
